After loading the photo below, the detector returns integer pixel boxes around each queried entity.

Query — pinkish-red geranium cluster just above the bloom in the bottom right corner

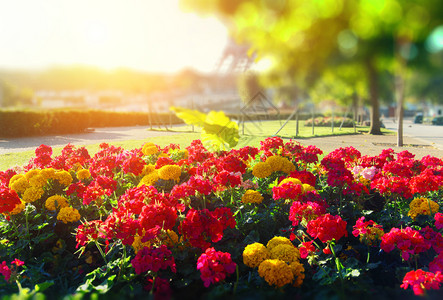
[380,227,431,260]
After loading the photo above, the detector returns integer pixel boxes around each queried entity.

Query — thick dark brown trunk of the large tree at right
[366,59,382,135]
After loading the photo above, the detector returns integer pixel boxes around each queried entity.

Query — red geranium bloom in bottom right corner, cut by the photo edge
[400,269,443,296]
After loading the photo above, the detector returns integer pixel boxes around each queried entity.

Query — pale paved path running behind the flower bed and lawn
[0,121,443,159]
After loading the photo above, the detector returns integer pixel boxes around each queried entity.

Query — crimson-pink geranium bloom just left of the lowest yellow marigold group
[197,248,237,287]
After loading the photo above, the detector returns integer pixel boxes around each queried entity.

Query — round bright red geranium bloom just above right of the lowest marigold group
[307,214,348,243]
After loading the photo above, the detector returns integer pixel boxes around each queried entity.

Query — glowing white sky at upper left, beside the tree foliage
[0,0,228,72]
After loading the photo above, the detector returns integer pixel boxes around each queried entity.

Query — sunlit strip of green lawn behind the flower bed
[0,120,395,171]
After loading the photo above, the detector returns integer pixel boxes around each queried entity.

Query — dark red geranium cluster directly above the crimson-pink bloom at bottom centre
[179,207,236,251]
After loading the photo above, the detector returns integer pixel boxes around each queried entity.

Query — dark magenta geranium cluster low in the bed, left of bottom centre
[131,245,177,274]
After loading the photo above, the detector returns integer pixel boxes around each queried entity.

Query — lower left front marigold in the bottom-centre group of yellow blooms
[258,259,294,287]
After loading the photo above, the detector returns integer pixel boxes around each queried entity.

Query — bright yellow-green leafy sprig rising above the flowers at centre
[171,107,240,150]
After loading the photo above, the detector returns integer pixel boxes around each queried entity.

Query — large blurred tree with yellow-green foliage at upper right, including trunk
[182,0,443,134]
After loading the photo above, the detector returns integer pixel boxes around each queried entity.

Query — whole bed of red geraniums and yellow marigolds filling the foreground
[0,137,443,299]
